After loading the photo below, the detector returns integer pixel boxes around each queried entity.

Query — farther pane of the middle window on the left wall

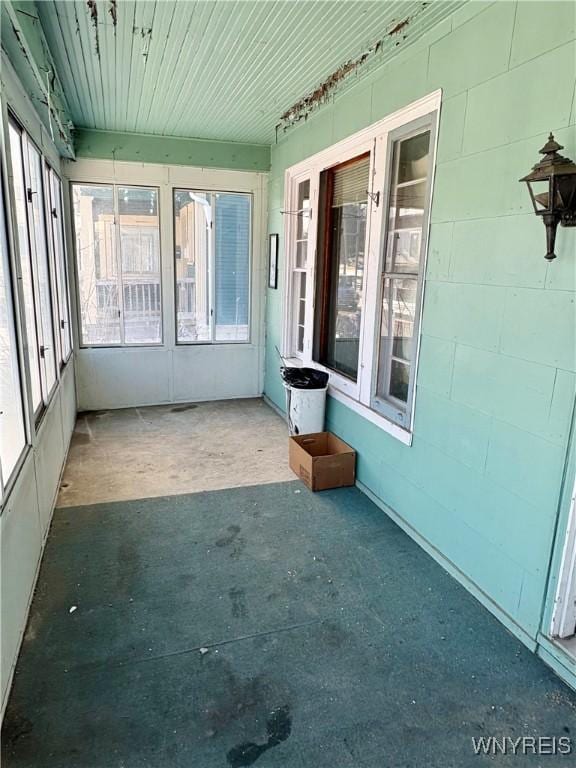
[28,142,56,401]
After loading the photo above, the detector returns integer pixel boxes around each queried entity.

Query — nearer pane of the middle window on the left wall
[10,124,42,412]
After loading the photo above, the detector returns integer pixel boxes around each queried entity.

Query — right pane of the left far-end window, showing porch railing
[118,187,162,344]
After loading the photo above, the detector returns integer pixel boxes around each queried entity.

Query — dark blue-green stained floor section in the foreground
[2,481,576,768]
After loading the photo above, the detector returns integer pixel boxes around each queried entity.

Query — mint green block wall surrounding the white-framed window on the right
[265,2,576,660]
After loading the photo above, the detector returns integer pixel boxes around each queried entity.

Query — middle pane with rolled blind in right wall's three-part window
[319,156,370,379]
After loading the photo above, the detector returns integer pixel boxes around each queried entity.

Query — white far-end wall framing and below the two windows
[62,159,267,410]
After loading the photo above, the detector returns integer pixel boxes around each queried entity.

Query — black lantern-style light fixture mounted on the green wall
[520,134,576,261]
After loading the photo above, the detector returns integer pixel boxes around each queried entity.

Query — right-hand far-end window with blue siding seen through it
[174,189,252,344]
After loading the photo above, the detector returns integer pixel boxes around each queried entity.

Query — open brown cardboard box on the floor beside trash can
[289,432,356,491]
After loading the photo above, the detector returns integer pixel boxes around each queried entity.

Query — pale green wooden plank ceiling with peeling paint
[36,0,459,144]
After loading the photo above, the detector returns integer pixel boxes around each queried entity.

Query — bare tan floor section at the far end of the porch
[57,399,294,507]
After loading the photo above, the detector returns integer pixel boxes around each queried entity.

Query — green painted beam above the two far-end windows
[74,128,270,171]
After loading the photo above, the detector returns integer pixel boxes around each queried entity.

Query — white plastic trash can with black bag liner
[281,366,328,435]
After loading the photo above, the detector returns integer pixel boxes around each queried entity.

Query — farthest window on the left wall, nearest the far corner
[46,167,72,364]
